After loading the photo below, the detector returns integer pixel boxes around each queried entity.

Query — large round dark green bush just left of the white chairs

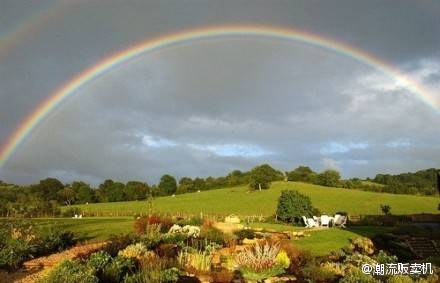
[277,190,313,224]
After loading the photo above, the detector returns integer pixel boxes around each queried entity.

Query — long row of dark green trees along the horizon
[0,164,438,217]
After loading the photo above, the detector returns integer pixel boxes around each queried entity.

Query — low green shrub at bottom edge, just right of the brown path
[39,260,98,283]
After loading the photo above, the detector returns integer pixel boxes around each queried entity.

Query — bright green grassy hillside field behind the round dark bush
[74,182,439,216]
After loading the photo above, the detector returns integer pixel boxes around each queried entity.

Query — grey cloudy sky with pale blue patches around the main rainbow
[0,0,440,185]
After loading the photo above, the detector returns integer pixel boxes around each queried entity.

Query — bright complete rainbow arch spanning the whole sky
[0,25,440,168]
